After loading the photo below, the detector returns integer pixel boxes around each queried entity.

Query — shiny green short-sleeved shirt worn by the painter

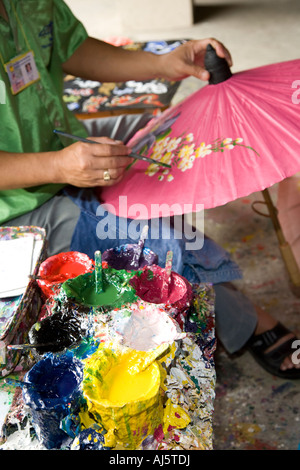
[0,0,87,224]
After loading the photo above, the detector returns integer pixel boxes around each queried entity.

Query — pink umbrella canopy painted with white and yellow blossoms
[99,50,300,219]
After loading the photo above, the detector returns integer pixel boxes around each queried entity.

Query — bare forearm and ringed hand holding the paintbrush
[0,137,133,190]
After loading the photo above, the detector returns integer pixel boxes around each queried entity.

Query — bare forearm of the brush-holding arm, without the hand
[0,151,58,190]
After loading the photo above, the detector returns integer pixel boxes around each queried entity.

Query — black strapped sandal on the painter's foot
[247,322,300,380]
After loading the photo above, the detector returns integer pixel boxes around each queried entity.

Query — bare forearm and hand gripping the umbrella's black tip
[63,38,232,82]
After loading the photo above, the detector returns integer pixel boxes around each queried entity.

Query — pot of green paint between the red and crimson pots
[61,268,136,311]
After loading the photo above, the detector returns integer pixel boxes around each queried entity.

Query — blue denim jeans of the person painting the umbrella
[65,188,242,284]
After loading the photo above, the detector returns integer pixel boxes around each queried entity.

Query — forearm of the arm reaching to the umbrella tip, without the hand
[63,38,161,82]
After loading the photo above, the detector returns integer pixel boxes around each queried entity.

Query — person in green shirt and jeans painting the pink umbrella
[0,0,300,379]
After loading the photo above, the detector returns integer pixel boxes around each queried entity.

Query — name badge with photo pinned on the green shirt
[5,51,40,95]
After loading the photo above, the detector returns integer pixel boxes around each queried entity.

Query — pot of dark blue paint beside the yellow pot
[23,352,83,449]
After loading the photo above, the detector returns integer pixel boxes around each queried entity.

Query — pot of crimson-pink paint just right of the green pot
[129,265,193,313]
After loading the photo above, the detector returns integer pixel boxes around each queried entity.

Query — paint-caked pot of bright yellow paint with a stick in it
[83,344,165,450]
